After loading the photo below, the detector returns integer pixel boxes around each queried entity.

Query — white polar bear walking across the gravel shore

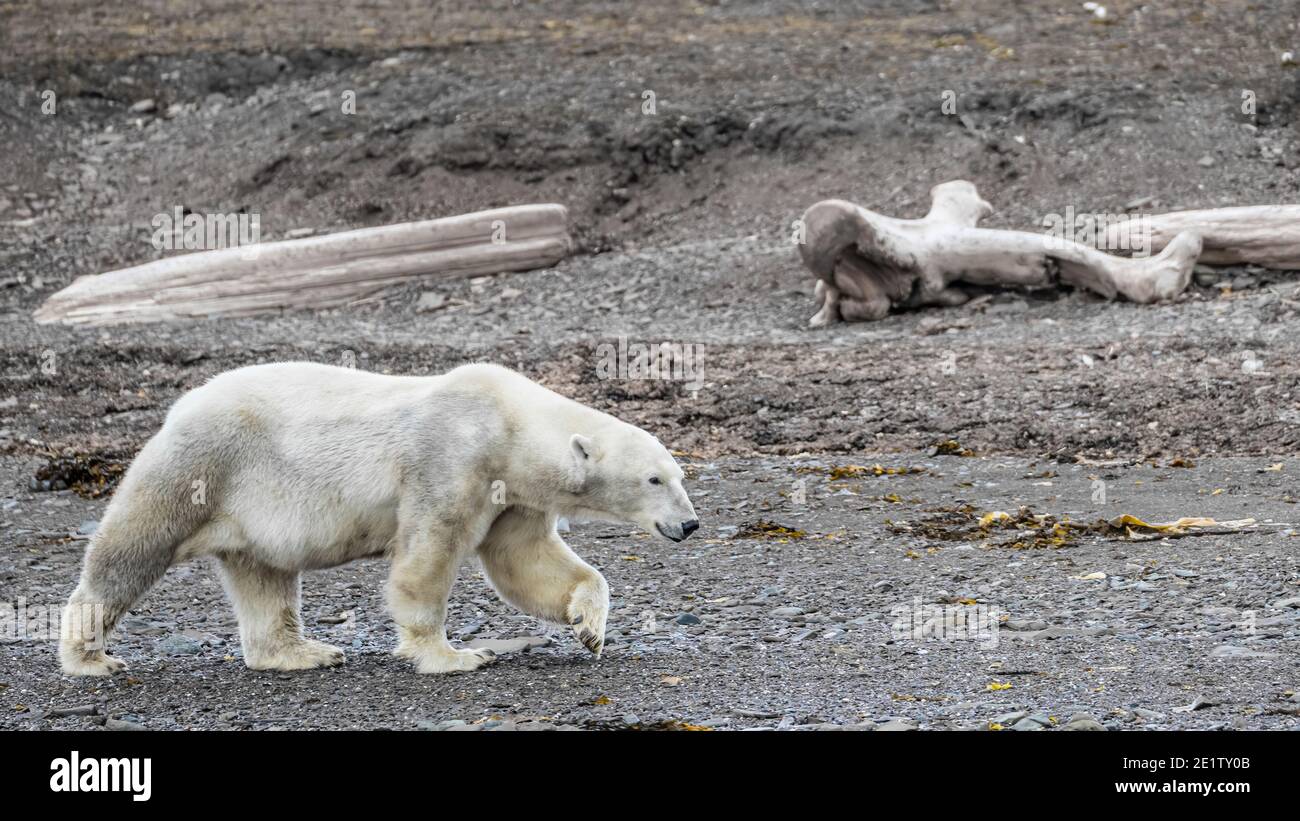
[60,362,699,676]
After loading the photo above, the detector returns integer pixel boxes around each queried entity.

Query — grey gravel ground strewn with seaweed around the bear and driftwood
[0,0,1300,729]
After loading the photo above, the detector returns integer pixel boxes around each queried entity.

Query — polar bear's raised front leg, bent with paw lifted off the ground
[478,508,610,656]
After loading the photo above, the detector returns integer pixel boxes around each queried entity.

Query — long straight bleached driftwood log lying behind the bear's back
[35,204,573,325]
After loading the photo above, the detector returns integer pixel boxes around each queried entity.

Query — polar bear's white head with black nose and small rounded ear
[569,425,699,542]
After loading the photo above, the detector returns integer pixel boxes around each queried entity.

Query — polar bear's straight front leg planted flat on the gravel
[389,524,497,673]
